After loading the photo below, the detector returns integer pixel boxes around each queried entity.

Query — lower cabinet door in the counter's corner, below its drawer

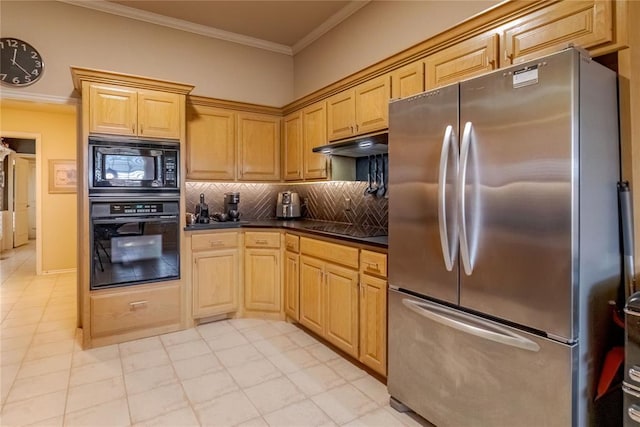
[244,248,281,312]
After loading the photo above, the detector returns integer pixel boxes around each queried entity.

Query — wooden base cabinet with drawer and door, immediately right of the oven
[191,231,240,318]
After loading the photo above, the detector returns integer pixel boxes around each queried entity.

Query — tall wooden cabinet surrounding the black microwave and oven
[71,67,193,348]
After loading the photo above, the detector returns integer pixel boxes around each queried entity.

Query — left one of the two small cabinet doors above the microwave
[89,85,138,136]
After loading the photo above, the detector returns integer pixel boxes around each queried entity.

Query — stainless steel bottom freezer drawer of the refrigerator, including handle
[387,290,577,427]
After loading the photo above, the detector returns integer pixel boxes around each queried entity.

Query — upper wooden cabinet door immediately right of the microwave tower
[187,106,236,180]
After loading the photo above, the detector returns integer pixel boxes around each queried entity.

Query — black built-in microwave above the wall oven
[88,136,180,196]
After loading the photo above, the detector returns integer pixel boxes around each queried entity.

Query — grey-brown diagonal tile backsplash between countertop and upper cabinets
[186,181,388,228]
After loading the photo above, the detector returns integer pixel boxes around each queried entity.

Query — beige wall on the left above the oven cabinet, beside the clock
[0,0,293,107]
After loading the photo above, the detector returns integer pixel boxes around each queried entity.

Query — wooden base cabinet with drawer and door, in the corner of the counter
[244,231,282,313]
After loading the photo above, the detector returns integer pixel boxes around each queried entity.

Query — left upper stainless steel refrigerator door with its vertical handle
[389,85,458,304]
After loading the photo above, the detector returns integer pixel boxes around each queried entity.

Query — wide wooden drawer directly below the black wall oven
[90,285,181,338]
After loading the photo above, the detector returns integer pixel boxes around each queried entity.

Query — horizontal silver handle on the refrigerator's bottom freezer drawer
[402,298,540,352]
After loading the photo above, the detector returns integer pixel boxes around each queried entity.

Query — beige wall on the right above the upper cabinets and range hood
[293,0,500,99]
